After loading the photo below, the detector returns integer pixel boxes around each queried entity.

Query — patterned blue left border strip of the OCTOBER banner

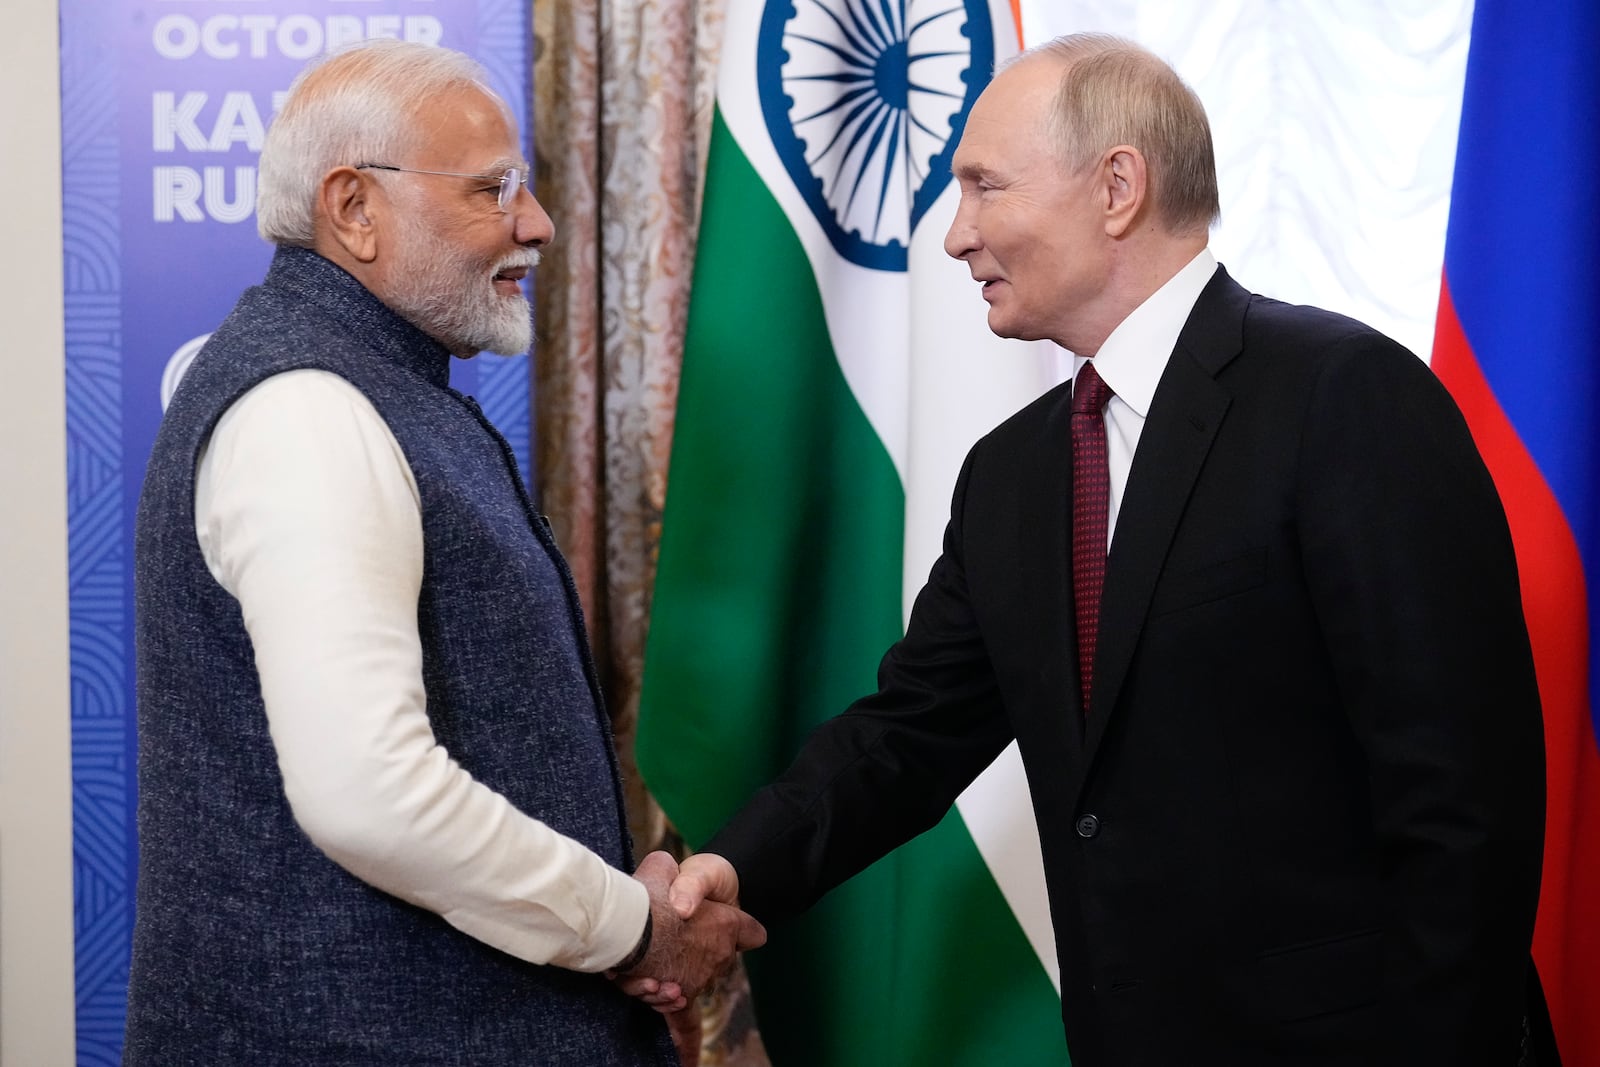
[61,0,134,1065]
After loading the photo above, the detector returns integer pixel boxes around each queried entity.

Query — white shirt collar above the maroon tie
[1072,248,1216,419]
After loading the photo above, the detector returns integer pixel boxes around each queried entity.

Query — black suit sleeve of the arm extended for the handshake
[704,443,1013,923]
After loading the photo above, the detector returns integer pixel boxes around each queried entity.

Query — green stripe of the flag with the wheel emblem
[638,114,1067,1067]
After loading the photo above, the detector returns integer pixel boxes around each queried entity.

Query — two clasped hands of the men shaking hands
[610,853,766,1013]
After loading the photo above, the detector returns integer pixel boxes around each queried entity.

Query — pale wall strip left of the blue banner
[0,0,74,1067]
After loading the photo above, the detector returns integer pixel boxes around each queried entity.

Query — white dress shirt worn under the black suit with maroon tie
[1072,248,1216,550]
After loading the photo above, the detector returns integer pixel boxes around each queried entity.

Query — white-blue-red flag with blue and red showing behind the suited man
[1432,0,1600,1067]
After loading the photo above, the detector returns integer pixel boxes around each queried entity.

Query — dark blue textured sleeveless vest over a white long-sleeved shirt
[125,248,677,1067]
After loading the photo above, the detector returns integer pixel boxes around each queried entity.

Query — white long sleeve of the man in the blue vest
[195,370,650,971]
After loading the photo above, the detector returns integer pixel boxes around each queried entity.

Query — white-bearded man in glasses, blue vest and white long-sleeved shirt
[125,42,765,1067]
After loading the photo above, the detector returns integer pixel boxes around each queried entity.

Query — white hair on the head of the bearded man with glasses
[256,38,493,248]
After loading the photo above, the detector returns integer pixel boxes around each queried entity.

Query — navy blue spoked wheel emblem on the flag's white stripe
[757,0,994,270]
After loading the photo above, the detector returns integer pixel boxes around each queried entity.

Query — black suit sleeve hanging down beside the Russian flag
[1298,334,1544,1064]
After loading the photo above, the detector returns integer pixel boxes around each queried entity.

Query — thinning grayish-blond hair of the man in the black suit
[1000,34,1222,235]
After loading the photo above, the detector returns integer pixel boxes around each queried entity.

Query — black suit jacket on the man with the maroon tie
[707,269,1544,1067]
